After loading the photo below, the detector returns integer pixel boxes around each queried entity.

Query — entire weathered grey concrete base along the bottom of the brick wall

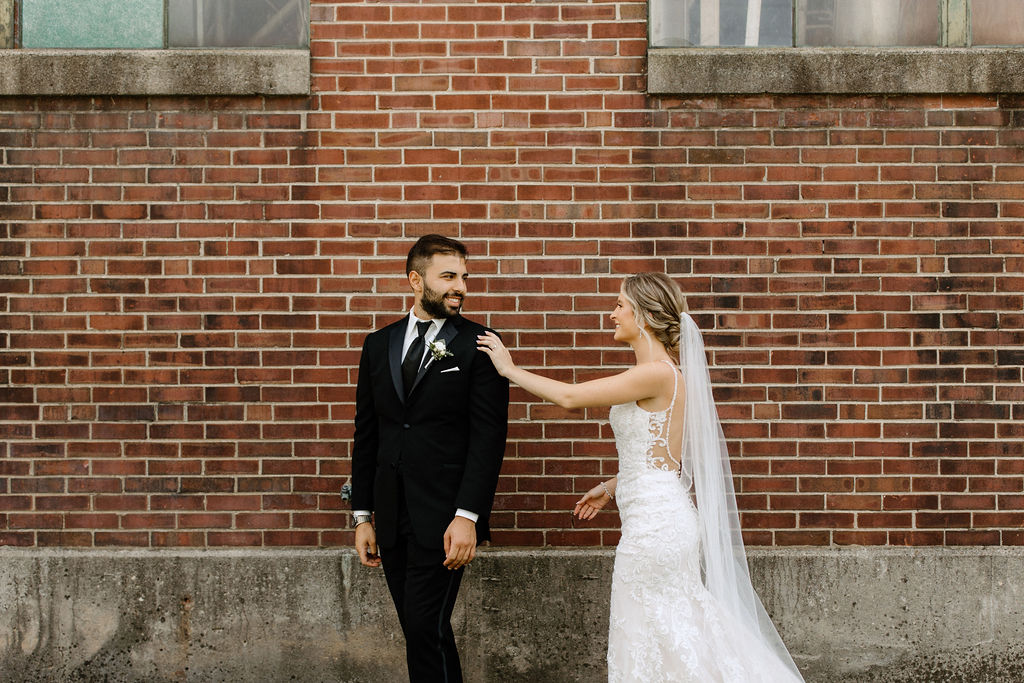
[0,548,1024,683]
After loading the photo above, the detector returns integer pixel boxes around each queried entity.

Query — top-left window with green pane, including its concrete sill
[0,0,310,95]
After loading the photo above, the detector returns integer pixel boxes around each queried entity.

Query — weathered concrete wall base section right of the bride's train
[751,548,1024,683]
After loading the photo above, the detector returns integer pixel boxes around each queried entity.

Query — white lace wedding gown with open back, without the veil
[608,360,800,683]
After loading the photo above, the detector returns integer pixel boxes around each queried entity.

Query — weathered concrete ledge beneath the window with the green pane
[0,49,309,95]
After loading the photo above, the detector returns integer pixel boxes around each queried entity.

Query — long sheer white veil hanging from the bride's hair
[679,312,803,681]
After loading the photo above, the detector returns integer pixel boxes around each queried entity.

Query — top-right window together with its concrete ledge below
[647,0,1024,94]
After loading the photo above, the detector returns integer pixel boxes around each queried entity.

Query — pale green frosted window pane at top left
[20,0,164,48]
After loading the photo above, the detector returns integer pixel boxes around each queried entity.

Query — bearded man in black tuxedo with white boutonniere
[352,234,509,683]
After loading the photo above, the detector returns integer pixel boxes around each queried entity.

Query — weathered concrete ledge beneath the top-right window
[647,47,1024,94]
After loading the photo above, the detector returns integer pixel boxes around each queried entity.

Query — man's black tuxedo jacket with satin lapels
[352,315,509,548]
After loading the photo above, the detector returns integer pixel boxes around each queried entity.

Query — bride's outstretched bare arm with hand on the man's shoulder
[476,332,673,409]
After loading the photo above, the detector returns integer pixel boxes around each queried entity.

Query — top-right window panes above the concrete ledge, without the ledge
[650,0,1024,47]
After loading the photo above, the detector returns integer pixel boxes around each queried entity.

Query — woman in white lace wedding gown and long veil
[477,272,803,683]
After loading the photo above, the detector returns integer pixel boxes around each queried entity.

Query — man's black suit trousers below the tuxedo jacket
[379,477,464,683]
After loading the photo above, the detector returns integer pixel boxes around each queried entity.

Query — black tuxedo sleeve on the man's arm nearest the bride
[456,331,509,517]
